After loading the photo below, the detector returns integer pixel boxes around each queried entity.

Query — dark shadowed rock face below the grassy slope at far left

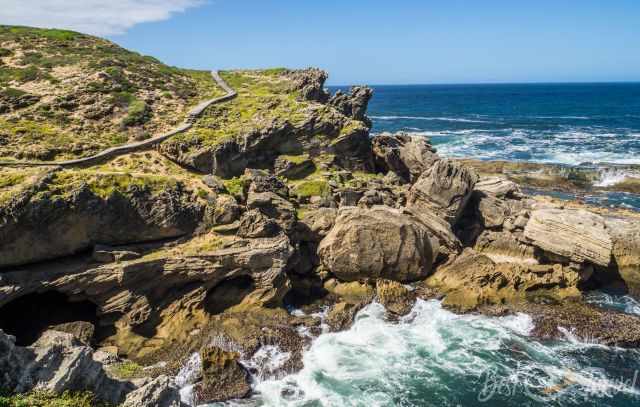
[0,172,206,267]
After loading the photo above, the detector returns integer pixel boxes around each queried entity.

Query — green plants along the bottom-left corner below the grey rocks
[0,391,109,407]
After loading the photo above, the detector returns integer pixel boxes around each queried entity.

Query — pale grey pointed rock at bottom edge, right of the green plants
[122,375,186,407]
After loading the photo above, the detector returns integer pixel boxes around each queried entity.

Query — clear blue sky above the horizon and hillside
[0,0,640,84]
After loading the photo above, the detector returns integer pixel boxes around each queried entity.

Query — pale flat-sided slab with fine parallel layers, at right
[524,209,613,267]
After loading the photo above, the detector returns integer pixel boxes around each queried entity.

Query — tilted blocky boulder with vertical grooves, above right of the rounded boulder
[407,160,478,224]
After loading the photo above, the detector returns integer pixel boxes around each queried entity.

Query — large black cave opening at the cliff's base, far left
[0,291,98,346]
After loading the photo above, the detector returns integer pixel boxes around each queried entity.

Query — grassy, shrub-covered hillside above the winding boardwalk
[0,26,224,161]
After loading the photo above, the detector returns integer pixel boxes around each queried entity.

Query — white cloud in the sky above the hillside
[0,0,202,35]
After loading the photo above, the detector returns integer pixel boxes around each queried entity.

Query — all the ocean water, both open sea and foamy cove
[188,84,640,407]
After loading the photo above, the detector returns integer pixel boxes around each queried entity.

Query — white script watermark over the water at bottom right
[477,367,640,403]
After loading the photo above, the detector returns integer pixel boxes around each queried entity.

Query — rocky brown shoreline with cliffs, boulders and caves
[0,70,640,406]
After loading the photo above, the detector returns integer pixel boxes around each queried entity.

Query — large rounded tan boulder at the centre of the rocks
[318,206,438,281]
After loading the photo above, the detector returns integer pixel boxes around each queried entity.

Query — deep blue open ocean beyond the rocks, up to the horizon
[331,83,640,210]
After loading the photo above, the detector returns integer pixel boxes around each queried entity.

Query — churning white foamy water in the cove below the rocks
[204,297,640,407]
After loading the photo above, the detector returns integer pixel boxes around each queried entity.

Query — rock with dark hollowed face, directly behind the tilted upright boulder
[372,133,440,182]
